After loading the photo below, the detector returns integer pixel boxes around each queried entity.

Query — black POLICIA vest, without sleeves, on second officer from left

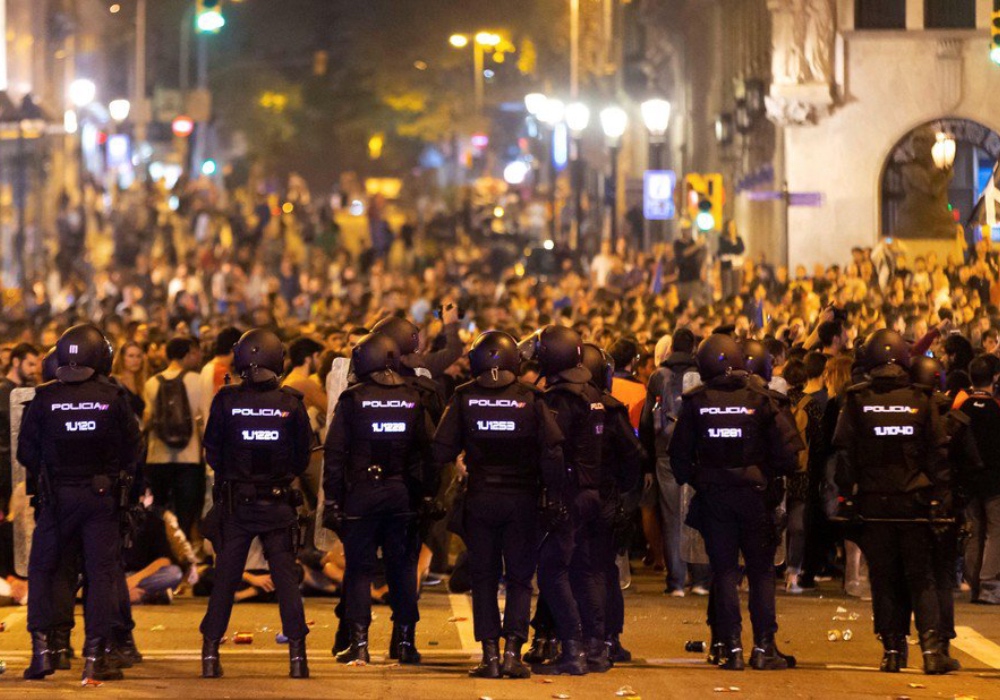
[217,385,309,483]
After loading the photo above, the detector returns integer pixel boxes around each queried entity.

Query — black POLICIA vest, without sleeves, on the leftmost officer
[35,381,131,479]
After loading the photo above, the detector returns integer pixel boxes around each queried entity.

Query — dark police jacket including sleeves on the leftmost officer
[17,375,141,482]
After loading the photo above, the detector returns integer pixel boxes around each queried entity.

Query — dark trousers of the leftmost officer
[28,484,121,639]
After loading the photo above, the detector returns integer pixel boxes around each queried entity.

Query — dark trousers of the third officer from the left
[342,479,420,625]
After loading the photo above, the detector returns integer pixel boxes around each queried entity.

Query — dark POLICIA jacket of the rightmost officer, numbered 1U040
[833,365,950,515]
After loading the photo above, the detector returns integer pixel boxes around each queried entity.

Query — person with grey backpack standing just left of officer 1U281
[639,328,711,597]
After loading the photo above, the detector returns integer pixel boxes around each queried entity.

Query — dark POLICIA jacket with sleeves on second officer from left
[204,381,312,485]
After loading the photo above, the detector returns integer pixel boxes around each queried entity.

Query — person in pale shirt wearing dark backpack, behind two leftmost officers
[144,338,205,538]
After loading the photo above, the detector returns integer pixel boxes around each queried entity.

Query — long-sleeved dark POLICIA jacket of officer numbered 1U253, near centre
[434,372,565,492]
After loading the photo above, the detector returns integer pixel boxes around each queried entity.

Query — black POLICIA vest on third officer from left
[341,382,424,483]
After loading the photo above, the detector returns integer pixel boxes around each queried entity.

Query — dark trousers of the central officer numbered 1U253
[465,491,538,641]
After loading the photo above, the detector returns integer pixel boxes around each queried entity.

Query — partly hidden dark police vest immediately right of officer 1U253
[547,382,605,489]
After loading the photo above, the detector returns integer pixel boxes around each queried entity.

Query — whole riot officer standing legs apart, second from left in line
[201,329,312,678]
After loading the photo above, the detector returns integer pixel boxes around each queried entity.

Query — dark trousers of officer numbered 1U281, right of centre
[703,487,778,640]
